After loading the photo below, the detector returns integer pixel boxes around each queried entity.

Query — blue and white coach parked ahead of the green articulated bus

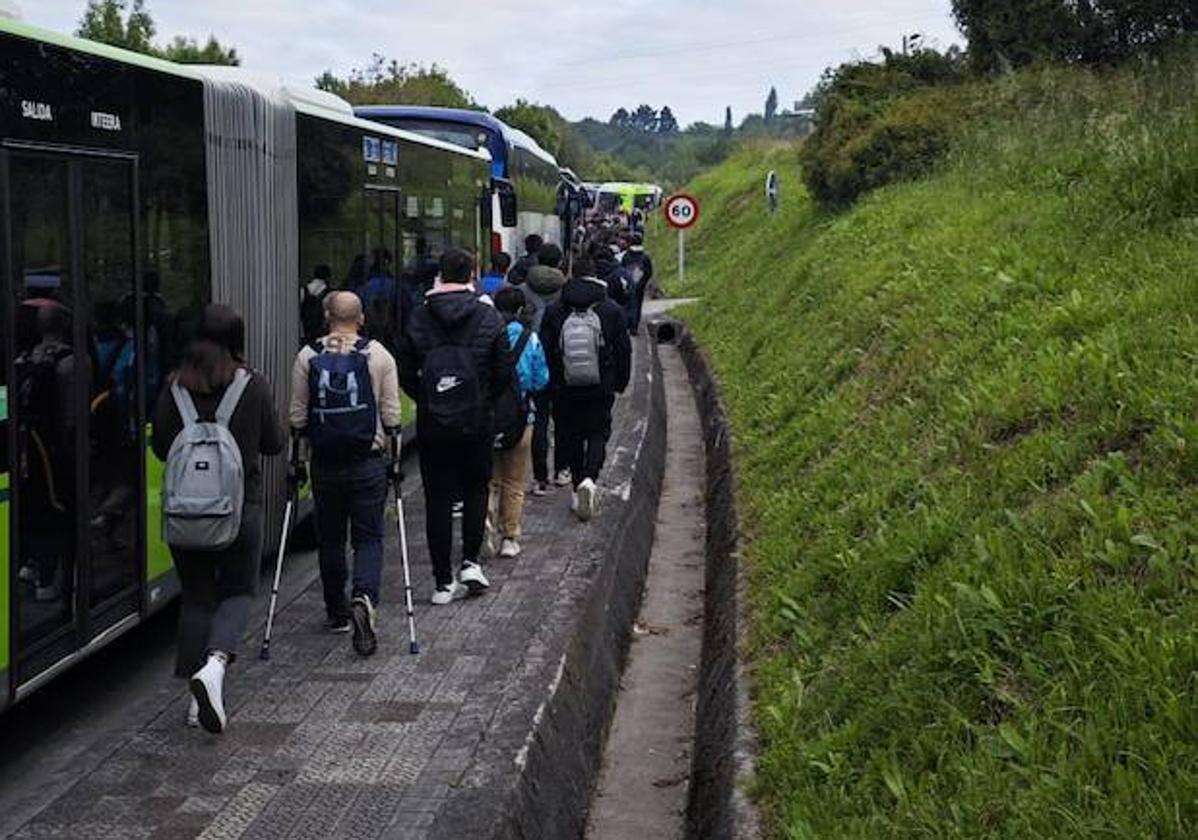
[355,105,565,259]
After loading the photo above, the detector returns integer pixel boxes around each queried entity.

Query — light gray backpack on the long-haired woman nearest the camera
[162,368,249,551]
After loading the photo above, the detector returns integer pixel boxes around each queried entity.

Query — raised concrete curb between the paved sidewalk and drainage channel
[421,339,666,840]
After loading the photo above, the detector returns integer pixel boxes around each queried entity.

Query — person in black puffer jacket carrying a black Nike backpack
[399,248,512,605]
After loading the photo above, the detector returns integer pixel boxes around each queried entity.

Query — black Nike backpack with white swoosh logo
[419,304,490,440]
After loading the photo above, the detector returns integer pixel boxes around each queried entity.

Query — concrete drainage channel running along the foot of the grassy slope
[586,320,760,840]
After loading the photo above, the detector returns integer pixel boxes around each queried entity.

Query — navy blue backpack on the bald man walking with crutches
[308,338,379,461]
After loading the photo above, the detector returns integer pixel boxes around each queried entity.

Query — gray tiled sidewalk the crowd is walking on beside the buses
[13,343,652,840]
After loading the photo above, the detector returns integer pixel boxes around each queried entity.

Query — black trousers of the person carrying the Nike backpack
[418,435,492,586]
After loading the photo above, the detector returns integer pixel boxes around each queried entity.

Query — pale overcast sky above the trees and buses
[17,0,960,125]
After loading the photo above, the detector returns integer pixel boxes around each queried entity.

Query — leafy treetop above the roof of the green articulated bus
[315,53,479,109]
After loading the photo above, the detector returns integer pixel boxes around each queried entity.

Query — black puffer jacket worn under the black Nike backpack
[395,291,513,425]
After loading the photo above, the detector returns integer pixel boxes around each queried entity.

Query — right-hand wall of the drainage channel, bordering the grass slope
[670,321,761,840]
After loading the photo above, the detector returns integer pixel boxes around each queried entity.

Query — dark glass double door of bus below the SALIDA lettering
[0,145,147,697]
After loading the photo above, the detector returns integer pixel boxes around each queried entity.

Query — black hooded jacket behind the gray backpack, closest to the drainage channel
[540,277,633,394]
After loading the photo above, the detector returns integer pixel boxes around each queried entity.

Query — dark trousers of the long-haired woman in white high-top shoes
[170,503,262,678]
